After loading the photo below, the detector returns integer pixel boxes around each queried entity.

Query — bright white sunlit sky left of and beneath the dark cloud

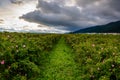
[0,0,66,33]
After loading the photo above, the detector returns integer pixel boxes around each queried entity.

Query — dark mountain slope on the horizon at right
[73,21,120,33]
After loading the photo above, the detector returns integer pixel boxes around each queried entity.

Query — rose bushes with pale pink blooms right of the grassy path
[65,34,120,80]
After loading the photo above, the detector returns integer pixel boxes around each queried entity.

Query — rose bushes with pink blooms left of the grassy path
[0,33,59,80]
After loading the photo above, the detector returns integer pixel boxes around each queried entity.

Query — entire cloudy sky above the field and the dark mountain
[0,0,120,33]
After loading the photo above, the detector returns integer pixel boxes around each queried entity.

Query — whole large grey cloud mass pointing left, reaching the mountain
[20,0,120,30]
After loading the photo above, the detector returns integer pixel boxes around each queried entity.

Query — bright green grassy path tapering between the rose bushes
[39,38,77,80]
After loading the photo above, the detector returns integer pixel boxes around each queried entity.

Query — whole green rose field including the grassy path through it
[0,32,120,80]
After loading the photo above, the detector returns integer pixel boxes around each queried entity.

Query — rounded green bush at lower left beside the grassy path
[10,60,40,79]
